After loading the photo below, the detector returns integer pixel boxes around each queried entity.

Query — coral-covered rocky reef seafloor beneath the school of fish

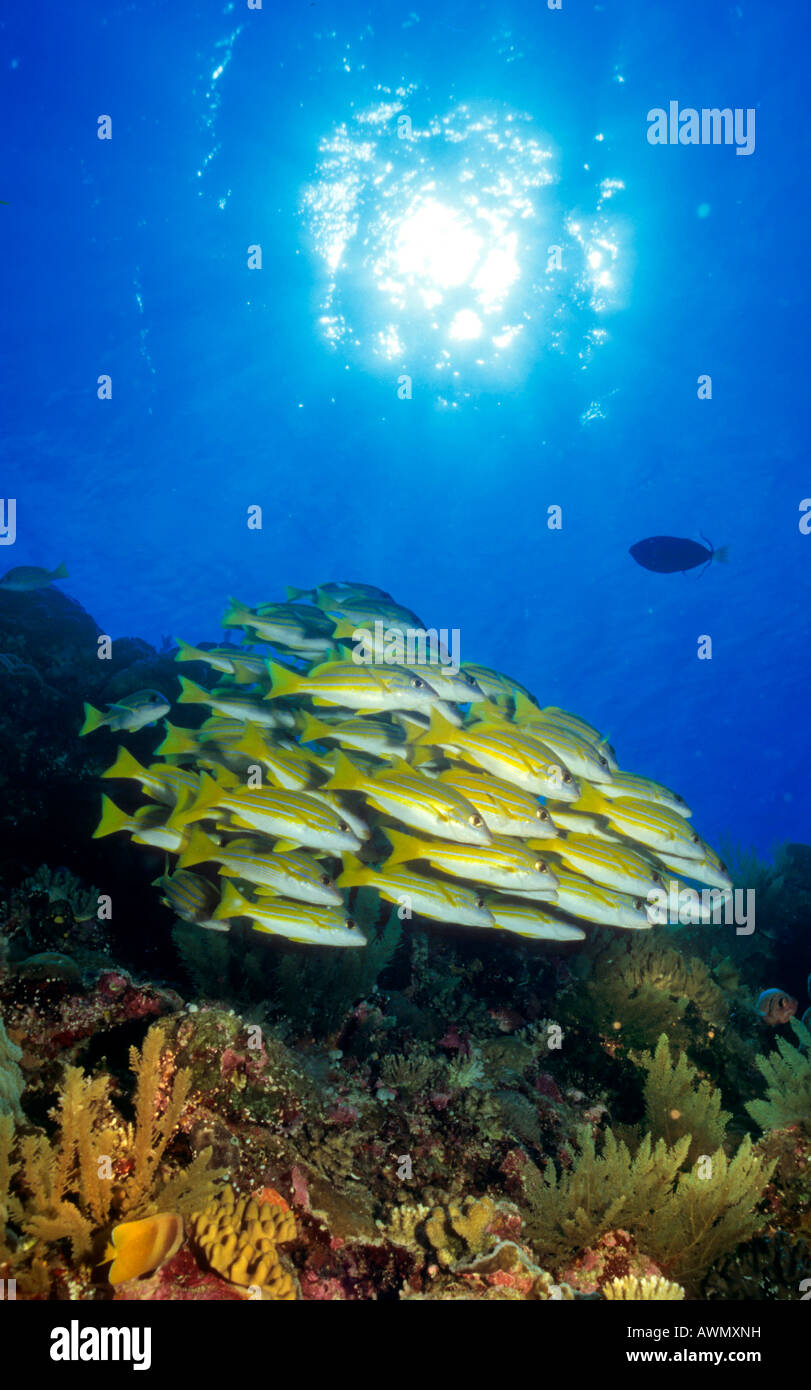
[0,589,811,1301]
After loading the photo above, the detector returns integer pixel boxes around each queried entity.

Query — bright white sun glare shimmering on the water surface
[303,89,627,400]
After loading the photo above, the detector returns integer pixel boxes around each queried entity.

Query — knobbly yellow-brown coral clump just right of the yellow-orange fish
[191,1184,296,1302]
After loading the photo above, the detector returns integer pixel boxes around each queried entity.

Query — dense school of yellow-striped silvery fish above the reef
[81,581,732,947]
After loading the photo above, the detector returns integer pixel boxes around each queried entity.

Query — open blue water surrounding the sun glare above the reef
[0,0,811,851]
